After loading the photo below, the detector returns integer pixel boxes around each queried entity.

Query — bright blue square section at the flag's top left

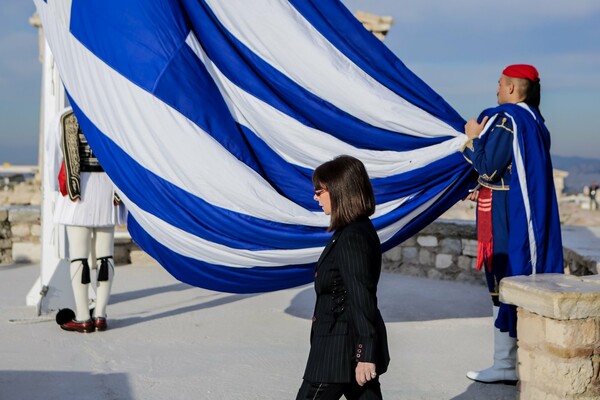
[70,0,190,92]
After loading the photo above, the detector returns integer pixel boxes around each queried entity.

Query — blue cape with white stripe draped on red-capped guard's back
[479,104,564,336]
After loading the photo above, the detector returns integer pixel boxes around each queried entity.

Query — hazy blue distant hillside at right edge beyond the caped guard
[552,154,600,193]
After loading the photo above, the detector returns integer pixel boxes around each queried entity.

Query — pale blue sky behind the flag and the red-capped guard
[0,0,600,164]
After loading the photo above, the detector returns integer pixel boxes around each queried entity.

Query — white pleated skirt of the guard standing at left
[54,172,127,227]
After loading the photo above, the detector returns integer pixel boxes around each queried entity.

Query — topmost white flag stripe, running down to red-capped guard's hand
[206,0,459,137]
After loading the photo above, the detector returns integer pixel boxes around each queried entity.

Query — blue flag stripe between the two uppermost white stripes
[182,0,448,150]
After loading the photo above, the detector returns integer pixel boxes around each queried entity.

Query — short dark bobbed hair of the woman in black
[312,155,375,231]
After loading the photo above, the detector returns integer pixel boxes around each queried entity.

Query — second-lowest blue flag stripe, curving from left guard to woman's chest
[69,98,330,250]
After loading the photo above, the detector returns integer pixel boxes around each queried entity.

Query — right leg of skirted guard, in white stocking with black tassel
[94,227,115,331]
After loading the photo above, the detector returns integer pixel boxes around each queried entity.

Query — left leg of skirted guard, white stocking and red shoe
[61,226,94,332]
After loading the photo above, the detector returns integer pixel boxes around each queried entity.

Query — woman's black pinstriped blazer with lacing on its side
[304,217,390,383]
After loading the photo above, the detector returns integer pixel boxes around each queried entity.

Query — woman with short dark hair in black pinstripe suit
[296,156,390,400]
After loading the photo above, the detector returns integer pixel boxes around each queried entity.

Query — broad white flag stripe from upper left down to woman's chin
[37,1,328,226]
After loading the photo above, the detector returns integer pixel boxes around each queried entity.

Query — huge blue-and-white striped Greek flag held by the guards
[35,0,471,293]
